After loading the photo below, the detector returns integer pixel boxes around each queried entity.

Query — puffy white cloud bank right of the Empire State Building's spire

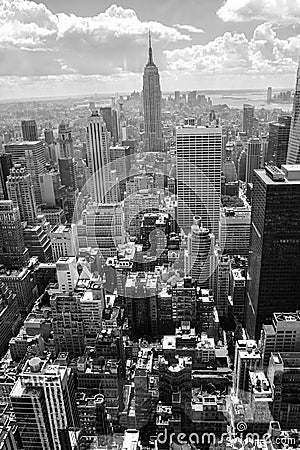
[165,23,300,75]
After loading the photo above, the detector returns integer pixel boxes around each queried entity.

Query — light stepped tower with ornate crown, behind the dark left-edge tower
[7,164,37,225]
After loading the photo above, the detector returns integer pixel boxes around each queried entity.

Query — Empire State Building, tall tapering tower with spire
[143,33,163,152]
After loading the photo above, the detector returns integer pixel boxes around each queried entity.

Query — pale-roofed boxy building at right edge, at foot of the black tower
[260,311,300,366]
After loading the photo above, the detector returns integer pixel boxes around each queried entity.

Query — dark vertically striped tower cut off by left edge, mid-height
[0,200,29,269]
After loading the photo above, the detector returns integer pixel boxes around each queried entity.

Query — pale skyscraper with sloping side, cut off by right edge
[286,64,300,164]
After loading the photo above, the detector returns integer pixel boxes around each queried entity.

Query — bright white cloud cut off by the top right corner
[217,0,300,24]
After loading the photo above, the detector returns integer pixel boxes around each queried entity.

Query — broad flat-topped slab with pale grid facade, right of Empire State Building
[176,119,222,239]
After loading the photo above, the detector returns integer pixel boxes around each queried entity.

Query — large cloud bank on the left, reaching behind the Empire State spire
[0,0,191,76]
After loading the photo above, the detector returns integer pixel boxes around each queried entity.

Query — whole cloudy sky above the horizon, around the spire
[0,0,300,98]
